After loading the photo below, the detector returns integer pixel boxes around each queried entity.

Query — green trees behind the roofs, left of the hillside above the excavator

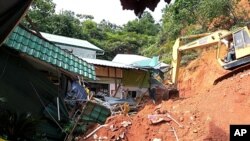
[23,0,160,60]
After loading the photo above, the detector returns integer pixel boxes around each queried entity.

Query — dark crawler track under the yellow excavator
[214,63,250,85]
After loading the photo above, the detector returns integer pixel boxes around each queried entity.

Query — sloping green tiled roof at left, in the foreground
[4,26,95,80]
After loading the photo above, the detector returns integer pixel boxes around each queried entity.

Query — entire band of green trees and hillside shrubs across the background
[23,0,249,63]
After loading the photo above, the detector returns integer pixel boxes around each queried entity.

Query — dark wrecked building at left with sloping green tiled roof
[0,25,110,140]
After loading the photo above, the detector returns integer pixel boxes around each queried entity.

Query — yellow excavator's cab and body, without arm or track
[217,27,250,70]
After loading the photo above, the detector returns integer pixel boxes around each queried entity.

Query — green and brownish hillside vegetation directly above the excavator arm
[154,0,250,62]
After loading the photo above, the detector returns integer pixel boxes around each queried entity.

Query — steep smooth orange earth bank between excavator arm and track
[178,48,228,97]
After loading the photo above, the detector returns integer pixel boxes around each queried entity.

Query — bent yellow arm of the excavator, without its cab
[171,30,230,88]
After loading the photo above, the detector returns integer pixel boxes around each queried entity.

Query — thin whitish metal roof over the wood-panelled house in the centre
[82,58,136,69]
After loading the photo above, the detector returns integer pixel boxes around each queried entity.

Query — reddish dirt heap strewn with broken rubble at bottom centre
[82,100,188,141]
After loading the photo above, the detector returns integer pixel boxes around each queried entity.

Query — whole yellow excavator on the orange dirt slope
[171,27,250,89]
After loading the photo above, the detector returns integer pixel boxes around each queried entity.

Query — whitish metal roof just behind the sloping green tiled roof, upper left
[40,32,104,52]
